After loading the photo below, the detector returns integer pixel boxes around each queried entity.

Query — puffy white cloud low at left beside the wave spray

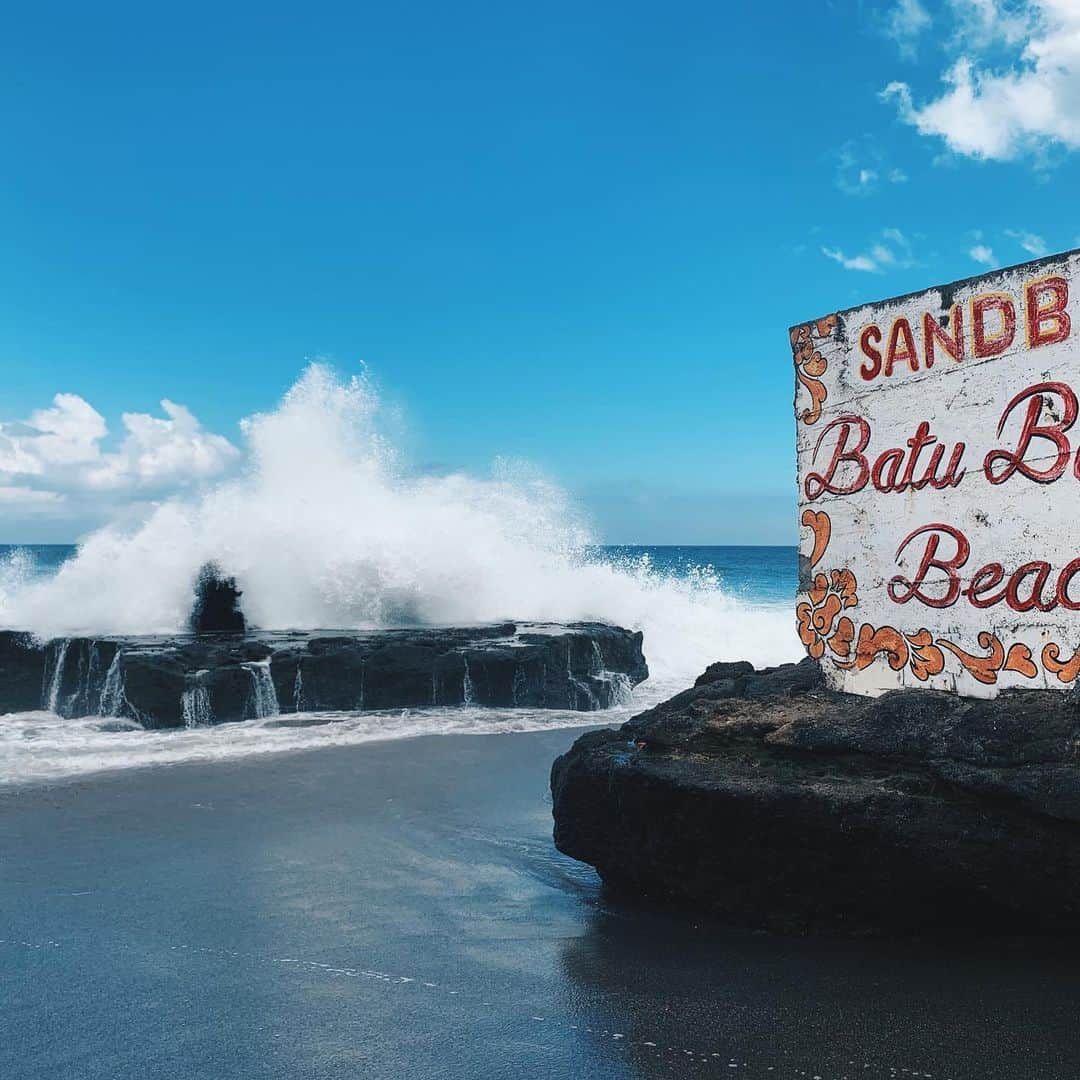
[0,393,240,522]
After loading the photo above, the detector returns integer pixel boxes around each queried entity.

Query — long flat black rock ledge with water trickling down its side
[0,623,648,728]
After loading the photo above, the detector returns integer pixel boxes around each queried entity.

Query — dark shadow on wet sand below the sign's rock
[562,900,1080,1080]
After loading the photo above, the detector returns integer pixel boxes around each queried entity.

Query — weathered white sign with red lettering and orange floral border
[791,252,1080,697]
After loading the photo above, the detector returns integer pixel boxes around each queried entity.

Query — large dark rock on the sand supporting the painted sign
[552,660,1080,932]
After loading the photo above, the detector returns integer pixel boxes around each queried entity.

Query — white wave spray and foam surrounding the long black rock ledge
[0,365,799,783]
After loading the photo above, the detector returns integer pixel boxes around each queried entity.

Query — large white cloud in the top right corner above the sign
[881,0,1080,161]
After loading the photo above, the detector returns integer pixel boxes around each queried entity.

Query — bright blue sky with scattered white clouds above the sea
[0,0,1080,543]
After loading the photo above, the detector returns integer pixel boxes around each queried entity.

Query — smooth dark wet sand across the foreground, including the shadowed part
[0,730,1080,1080]
